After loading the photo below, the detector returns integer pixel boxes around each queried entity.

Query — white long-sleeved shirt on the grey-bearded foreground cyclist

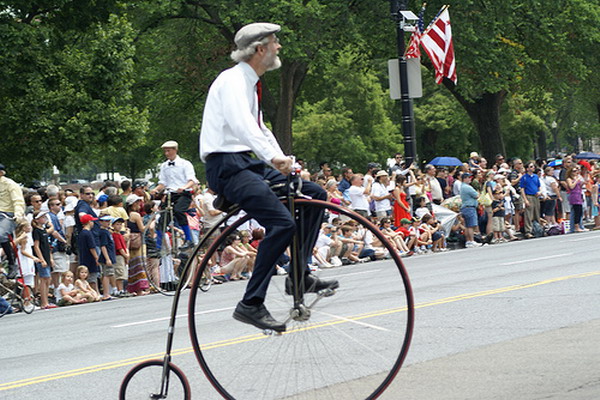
[200,62,285,164]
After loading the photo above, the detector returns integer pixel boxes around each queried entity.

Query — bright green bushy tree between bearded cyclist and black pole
[294,48,402,171]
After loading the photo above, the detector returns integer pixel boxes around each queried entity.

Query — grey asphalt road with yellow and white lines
[0,232,600,399]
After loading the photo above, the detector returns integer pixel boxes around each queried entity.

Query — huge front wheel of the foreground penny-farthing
[188,199,414,400]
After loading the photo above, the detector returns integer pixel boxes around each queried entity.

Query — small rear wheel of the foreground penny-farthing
[119,359,192,400]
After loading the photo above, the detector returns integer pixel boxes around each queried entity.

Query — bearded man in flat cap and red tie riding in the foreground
[200,23,339,332]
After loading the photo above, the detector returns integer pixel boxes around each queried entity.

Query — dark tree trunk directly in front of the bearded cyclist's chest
[263,61,308,154]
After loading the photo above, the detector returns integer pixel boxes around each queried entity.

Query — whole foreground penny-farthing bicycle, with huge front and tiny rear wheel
[120,173,414,400]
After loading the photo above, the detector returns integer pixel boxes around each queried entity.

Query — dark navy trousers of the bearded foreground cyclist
[206,153,327,304]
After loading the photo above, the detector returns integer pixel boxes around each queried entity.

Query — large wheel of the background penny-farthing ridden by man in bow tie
[142,212,193,296]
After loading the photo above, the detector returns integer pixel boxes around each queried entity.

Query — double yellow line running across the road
[0,271,600,391]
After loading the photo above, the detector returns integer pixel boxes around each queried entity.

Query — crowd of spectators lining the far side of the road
[0,152,600,309]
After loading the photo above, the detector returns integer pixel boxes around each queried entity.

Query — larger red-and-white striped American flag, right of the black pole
[421,6,457,85]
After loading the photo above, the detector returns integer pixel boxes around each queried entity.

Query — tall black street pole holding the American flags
[390,0,417,166]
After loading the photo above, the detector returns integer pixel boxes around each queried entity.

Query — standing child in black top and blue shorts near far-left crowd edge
[31,211,56,310]
